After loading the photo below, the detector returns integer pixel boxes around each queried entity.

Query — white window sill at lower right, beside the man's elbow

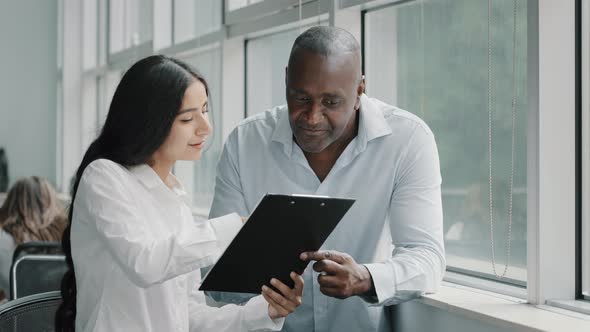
[417,282,590,332]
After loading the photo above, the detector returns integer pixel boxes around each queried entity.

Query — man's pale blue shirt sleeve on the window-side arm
[365,126,446,305]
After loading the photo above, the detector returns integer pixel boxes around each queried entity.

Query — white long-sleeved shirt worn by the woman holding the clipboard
[71,159,284,332]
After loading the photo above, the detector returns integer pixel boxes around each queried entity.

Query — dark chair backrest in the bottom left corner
[0,291,61,332]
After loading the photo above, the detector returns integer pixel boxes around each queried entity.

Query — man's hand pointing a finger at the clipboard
[299,250,374,299]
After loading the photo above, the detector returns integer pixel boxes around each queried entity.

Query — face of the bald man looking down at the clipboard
[286,50,364,153]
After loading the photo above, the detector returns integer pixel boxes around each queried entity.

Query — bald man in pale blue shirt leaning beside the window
[210,27,445,332]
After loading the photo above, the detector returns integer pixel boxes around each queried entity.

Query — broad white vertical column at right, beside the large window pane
[527,0,576,304]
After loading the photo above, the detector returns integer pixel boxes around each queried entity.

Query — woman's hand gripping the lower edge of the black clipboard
[262,272,303,319]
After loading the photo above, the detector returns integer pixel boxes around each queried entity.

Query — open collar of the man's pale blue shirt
[272,93,392,156]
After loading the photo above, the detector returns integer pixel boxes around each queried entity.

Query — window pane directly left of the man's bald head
[246,29,299,116]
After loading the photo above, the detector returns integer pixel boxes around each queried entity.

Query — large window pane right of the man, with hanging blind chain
[365,0,528,283]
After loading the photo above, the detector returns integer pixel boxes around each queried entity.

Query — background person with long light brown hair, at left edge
[0,176,67,300]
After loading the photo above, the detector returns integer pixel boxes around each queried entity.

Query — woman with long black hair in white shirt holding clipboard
[56,56,303,332]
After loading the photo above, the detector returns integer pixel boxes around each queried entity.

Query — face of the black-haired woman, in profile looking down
[153,80,212,162]
